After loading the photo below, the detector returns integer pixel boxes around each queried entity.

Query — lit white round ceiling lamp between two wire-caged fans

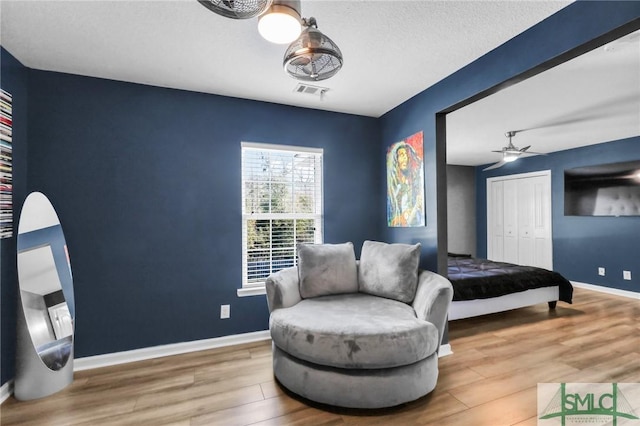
[258,0,302,44]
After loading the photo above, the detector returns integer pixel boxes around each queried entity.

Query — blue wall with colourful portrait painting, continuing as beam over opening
[378,1,640,272]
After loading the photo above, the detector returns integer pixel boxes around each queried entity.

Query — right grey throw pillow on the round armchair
[358,241,420,303]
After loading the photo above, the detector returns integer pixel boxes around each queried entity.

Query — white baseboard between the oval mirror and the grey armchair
[73,330,271,371]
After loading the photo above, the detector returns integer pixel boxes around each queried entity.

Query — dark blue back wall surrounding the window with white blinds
[28,70,381,357]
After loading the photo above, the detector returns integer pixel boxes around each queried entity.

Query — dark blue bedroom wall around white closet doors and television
[476,137,640,292]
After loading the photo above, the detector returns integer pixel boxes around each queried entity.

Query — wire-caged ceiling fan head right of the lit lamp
[283,18,343,81]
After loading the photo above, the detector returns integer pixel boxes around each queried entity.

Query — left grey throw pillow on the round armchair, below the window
[298,242,358,299]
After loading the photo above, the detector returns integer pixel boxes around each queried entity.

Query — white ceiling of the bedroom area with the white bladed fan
[447,27,640,166]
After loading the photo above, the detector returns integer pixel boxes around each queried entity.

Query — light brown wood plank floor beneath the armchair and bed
[0,289,640,426]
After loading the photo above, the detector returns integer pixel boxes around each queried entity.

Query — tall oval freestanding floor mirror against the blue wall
[14,192,75,400]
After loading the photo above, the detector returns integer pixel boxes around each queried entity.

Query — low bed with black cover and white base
[448,254,573,320]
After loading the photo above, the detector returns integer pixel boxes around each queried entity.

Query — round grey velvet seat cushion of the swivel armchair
[269,293,440,369]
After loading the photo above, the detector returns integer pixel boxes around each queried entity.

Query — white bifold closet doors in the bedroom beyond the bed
[487,170,553,269]
